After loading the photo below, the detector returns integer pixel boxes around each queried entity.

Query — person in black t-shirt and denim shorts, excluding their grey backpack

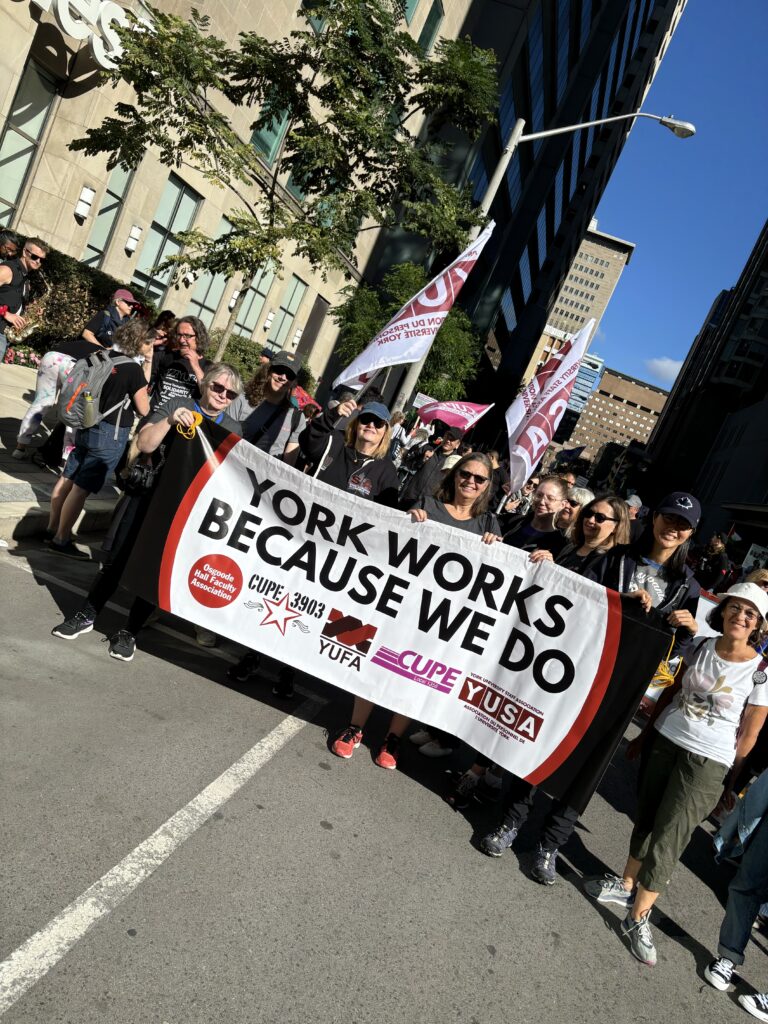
[48,321,153,560]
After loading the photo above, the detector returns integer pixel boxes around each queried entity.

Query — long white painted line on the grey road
[0,698,326,1016]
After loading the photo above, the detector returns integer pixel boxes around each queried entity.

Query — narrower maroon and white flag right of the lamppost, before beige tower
[506,319,595,490]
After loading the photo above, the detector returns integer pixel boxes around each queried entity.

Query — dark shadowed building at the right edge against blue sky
[649,223,768,543]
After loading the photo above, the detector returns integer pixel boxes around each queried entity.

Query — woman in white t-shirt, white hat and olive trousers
[585,583,768,967]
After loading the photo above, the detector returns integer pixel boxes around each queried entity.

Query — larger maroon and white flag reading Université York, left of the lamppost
[333,220,495,387]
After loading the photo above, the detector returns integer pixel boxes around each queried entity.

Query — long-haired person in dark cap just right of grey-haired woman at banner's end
[230,349,304,466]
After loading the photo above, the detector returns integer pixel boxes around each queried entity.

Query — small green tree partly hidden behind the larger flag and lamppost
[332,263,480,401]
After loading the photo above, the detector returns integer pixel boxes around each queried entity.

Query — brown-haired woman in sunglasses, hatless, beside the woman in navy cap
[481,495,630,872]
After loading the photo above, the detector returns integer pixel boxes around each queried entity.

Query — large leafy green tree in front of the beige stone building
[71,0,498,360]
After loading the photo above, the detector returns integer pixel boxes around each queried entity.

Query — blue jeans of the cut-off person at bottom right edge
[718,814,768,965]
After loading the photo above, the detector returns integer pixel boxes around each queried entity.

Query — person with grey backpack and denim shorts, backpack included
[47,321,153,559]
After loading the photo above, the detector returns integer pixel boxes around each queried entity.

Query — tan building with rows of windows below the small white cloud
[569,368,668,459]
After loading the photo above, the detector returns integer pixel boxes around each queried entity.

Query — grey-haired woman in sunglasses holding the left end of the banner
[51,362,243,662]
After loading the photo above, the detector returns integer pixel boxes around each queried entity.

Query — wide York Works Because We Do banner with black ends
[124,423,669,808]
